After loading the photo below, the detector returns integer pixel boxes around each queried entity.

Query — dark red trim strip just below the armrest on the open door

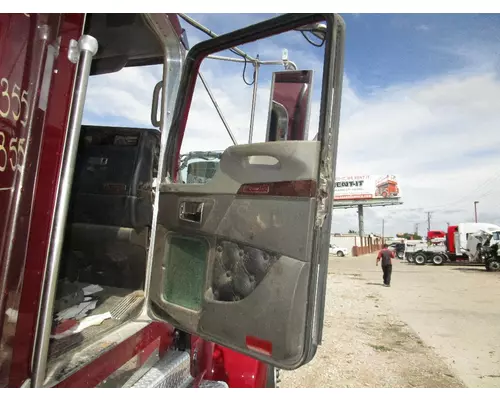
[238,180,316,197]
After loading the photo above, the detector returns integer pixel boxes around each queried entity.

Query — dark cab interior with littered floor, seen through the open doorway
[49,14,167,375]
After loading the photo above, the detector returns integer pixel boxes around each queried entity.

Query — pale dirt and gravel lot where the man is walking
[279,255,500,388]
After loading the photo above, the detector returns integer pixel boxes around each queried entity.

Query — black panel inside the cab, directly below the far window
[64,125,160,289]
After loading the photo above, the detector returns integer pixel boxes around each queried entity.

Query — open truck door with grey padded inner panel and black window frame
[146,14,344,369]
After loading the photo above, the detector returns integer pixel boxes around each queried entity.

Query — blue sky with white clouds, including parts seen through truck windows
[84,14,500,235]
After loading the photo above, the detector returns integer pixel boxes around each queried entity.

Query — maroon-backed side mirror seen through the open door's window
[266,70,313,142]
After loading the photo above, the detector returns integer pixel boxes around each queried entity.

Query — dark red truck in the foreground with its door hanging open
[0,14,344,387]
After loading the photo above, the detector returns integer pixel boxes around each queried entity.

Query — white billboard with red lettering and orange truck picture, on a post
[333,175,401,202]
